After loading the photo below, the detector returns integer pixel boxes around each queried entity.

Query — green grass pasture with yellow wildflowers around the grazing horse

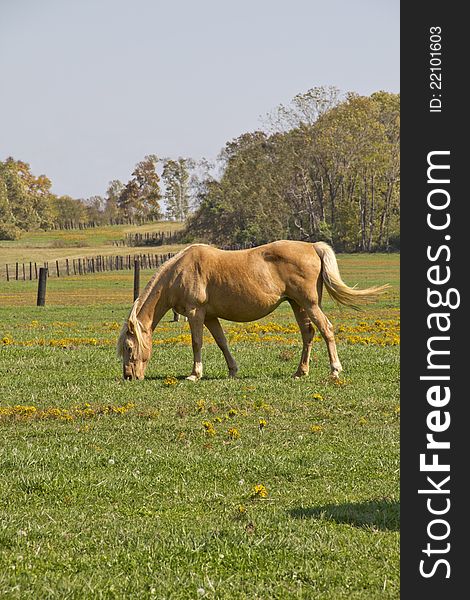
[0,246,400,600]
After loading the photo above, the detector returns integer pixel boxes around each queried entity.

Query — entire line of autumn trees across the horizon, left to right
[0,87,400,252]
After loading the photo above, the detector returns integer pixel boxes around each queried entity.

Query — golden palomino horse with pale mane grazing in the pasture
[117,240,388,381]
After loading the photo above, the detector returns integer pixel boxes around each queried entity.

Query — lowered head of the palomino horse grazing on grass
[117,301,152,379]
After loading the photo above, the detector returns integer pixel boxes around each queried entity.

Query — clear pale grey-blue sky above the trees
[0,0,400,198]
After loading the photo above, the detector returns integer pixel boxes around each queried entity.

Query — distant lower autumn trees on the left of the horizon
[0,154,198,239]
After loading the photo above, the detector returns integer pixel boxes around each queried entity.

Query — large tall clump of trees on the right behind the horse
[186,87,400,252]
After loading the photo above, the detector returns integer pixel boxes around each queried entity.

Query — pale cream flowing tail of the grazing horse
[313,242,390,310]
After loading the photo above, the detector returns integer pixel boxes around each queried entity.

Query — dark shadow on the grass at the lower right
[288,499,400,531]
